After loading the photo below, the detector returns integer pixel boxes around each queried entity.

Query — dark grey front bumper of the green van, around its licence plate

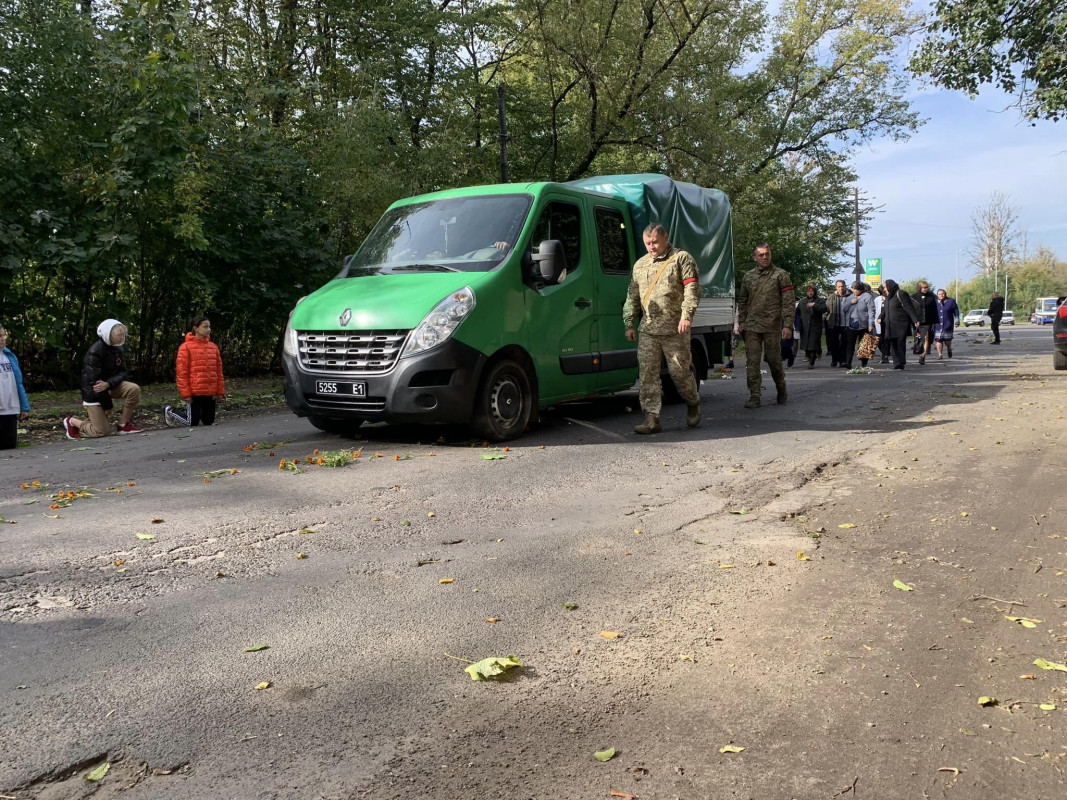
[282,339,485,422]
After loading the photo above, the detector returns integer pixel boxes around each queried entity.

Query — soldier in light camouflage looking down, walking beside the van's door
[622,224,700,433]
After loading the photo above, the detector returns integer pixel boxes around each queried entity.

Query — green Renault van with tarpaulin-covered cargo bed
[283,175,734,442]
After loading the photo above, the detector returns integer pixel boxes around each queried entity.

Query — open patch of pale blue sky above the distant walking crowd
[841,86,1067,288]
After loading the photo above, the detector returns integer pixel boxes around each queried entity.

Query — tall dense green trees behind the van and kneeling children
[0,0,919,382]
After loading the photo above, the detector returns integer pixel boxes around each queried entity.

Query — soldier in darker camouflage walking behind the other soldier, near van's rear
[737,244,796,409]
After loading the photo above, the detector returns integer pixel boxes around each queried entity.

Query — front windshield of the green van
[337,194,534,277]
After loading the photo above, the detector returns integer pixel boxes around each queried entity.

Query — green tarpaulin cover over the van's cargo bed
[567,174,734,298]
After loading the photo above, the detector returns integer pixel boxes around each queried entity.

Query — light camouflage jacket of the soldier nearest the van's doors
[622,247,700,336]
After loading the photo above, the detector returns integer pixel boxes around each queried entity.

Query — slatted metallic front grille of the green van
[297,331,408,375]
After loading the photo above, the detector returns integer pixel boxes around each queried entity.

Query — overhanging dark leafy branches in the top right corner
[911,0,1067,121]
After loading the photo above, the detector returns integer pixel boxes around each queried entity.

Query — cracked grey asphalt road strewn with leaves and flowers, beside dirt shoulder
[0,324,1062,799]
